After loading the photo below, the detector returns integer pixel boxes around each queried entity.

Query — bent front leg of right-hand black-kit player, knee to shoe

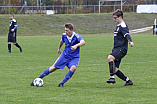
[106,55,116,84]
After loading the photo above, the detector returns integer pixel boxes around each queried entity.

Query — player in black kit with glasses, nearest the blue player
[106,9,134,86]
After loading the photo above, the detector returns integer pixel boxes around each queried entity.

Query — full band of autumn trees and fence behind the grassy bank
[0,0,157,14]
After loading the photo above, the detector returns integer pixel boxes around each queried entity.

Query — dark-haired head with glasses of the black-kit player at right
[113,9,123,23]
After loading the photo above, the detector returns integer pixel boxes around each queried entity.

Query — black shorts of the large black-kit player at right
[110,49,127,68]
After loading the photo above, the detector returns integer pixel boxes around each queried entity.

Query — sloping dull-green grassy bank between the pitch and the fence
[0,13,157,36]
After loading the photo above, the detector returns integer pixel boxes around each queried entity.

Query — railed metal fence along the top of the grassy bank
[0,4,137,14]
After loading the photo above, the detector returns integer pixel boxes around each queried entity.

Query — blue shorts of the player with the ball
[54,54,79,69]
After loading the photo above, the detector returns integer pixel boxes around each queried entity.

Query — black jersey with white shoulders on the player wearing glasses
[114,22,130,50]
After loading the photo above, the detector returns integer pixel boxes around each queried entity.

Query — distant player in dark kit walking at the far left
[8,14,22,53]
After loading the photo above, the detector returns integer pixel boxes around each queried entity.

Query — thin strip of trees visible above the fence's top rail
[0,0,157,6]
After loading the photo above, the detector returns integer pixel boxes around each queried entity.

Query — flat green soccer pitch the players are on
[0,35,157,104]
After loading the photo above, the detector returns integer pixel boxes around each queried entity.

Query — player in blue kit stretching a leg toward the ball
[31,23,85,87]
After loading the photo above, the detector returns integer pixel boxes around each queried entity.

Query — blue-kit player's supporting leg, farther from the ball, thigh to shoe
[58,58,79,87]
